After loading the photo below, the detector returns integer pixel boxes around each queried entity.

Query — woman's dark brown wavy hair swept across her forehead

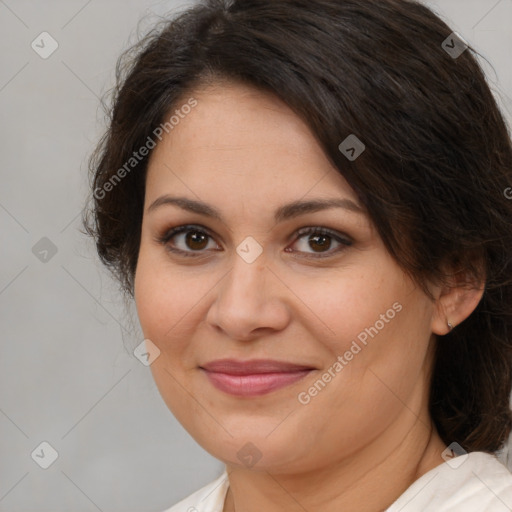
[82,0,512,453]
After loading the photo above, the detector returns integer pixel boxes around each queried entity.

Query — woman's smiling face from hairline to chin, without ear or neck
[135,84,440,472]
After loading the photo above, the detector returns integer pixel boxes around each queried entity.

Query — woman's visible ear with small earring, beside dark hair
[431,264,485,336]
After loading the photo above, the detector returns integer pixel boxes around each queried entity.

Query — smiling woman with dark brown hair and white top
[84,0,512,512]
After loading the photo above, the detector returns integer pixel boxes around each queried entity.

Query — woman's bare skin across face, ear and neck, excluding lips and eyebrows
[135,83,483,512]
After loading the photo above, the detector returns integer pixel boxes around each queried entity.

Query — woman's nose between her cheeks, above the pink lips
[207,254,290,341]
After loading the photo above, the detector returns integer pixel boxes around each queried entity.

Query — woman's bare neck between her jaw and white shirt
[223,416,445,512]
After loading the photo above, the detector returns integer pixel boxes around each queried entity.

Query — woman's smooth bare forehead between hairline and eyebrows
[146,83,357,212]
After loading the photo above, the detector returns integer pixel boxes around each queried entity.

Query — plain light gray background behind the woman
[0,0,512,512]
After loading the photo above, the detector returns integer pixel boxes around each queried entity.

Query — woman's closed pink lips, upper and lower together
[200,359,314,396]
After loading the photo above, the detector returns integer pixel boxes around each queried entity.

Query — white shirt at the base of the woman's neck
[164,452,512,512]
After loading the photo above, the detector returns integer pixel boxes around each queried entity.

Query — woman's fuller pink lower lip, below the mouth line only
[203,370,312,396]
